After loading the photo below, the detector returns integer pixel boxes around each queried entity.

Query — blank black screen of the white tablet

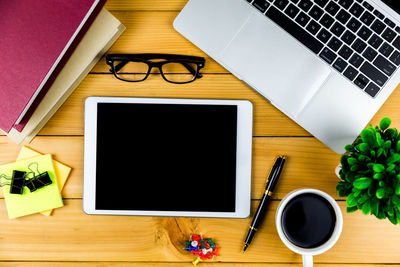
[96,103,237,212]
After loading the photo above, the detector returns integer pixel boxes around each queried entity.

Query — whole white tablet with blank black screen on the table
[83,97,253,218]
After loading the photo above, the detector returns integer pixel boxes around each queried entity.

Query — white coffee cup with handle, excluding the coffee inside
[275,189,343,267]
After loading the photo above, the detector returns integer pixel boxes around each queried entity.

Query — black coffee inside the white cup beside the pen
[282,193,336,248]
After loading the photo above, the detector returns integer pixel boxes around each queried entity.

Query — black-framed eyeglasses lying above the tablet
[106,54,206,84]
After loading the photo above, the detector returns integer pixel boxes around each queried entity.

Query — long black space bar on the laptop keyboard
[265,6,324,54]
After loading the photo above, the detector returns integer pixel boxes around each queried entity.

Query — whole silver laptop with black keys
[174,0,400,153]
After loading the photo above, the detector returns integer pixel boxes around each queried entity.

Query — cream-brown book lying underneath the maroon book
[7,9,125,144]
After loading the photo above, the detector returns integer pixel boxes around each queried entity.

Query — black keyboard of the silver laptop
[246,0,400,97]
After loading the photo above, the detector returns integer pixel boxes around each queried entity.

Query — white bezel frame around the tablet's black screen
[83,97,253,218]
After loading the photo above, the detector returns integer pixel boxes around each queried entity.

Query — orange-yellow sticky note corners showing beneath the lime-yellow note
[17,146,71,216]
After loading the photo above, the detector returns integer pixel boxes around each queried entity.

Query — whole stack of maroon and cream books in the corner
[0,0,125,144]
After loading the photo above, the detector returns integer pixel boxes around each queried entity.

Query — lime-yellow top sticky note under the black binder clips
[0,154,64,219]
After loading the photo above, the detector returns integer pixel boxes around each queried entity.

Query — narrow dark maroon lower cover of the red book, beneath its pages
[13,0,106,132]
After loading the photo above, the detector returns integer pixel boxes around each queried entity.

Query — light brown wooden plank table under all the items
[0,0,400,267]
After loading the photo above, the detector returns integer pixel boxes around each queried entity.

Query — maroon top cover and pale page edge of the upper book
[0,0,99,132]
